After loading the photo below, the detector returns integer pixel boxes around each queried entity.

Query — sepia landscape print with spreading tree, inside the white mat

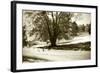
[22,10,91,63]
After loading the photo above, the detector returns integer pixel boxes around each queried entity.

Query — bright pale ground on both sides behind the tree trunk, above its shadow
[28,33,91,48]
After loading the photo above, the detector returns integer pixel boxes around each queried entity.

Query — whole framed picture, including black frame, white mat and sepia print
[11,1,98,72]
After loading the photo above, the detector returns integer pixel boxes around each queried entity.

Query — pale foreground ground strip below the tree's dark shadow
[23,48,91,61]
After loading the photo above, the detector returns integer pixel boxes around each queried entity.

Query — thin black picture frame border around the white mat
[11,1,98,72]
